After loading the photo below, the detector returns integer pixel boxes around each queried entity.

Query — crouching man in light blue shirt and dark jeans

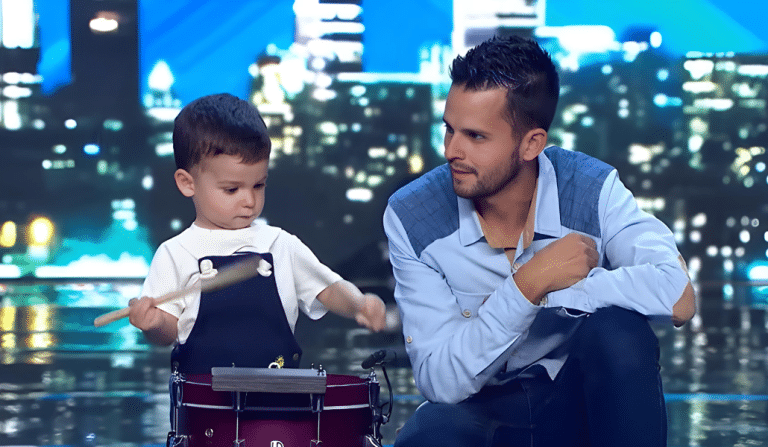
[384,37,695,447]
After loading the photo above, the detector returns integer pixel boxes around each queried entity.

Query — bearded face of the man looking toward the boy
[443,85,522,199]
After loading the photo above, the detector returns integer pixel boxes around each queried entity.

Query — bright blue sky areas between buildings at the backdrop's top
[36,0,768,104]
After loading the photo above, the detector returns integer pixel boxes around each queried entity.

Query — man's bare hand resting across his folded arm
[514,233,598,305]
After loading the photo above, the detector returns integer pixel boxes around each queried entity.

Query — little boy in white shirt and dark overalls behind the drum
[129,94,385,374]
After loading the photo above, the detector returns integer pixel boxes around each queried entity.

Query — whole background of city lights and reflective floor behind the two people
[0,0,768,447]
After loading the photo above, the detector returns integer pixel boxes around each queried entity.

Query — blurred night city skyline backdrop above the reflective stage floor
[0,0,768,288]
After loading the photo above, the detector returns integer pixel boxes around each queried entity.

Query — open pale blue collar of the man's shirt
[456,151,561,247]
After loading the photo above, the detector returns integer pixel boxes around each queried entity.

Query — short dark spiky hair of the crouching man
[450,36,560,132]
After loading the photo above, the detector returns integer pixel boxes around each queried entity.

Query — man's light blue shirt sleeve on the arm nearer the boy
[384,207,541,403]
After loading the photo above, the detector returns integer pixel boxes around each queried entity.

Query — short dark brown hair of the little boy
[173,93,272,171]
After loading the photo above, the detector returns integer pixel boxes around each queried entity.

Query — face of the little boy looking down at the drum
[176,155,269,230]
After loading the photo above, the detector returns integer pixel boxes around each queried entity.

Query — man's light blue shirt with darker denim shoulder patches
[384,147,689,403]
